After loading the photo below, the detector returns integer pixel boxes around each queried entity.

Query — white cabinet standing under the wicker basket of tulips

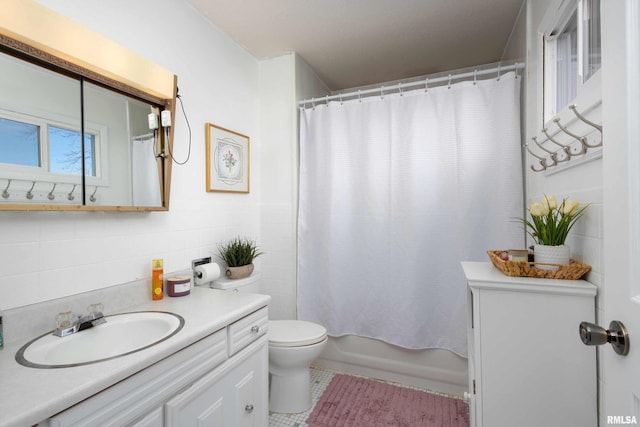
[462,262,597,427]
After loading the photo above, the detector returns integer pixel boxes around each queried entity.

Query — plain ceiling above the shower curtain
[186,0,523,90]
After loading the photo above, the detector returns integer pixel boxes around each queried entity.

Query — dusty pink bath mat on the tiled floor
[307,374,469,427]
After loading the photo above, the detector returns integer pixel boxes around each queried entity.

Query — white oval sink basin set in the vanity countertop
[16,311,184,368]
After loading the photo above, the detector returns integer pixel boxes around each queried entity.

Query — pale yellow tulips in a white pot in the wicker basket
[518,196,589,270]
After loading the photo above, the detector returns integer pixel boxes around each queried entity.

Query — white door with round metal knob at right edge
[598,0,640,426]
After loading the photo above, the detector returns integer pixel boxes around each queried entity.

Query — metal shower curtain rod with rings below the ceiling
[298,62,524,108]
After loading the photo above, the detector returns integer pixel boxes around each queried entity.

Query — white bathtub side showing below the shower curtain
[313,335,468,397]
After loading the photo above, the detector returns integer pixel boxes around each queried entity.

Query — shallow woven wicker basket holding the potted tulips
[487,251,591,280]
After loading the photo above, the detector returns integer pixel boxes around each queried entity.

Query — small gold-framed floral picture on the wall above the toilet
[206,123,250,193]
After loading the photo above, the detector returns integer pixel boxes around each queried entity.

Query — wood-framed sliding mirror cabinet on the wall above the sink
[0,0,177,211]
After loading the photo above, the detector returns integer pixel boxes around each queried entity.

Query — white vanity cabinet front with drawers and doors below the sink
[45,307,269,427]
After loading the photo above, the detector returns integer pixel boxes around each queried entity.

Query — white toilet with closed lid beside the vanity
[211,272,327,414]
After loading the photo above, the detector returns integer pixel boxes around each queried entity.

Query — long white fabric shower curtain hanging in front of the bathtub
[298,73,524,356]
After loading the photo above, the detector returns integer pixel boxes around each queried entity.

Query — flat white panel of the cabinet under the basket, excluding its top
[474,289,597,427]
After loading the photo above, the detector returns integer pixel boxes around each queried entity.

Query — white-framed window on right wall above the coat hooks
[544,0,601,123]
